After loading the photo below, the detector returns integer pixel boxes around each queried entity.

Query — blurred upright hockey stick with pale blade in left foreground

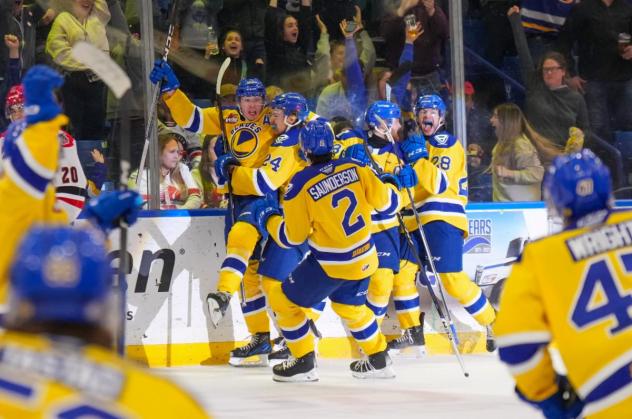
[72,41,132,356]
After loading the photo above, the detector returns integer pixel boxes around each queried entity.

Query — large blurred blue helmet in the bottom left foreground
[8,226,112,324]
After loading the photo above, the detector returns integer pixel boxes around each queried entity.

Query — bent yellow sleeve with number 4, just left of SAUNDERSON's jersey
[231,134,300,196]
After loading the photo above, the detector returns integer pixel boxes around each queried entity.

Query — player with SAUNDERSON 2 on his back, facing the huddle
[239,119,416,381]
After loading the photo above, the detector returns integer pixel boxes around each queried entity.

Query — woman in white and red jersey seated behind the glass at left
[130,133,202,209]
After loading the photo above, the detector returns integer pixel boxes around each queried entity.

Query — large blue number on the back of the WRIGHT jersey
[571,253,632,334]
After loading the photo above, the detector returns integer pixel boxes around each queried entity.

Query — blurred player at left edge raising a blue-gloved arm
[0,66,68,311]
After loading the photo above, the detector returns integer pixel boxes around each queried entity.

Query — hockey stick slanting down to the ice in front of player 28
[375,115,470,377]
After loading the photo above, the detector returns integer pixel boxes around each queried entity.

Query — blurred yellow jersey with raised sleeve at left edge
[0,115,68,311]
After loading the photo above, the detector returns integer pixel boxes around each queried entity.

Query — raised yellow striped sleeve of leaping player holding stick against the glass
[165,89,226,135]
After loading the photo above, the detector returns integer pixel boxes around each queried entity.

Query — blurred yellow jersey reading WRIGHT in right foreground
[494,211,632,418]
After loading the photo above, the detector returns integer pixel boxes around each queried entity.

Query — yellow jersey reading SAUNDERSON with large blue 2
[267,159,401,280]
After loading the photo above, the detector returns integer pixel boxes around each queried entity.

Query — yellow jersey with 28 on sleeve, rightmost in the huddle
[404,131,468,235]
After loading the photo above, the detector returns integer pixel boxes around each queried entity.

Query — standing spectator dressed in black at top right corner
[557,0,632,141]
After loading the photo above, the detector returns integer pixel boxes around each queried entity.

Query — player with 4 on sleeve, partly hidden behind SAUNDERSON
[209,92,326,366]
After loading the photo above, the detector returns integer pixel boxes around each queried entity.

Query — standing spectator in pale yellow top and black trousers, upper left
[46,0,110,142]
